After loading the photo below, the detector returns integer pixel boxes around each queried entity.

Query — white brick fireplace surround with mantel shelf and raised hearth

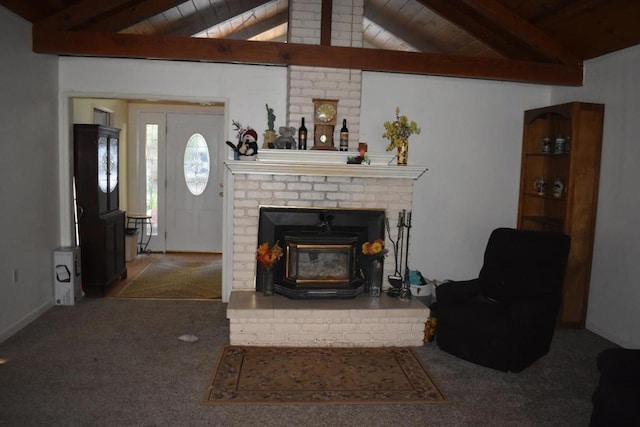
[225,150,429,346]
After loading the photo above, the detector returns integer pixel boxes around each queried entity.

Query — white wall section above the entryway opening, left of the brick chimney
[60,57,287,138]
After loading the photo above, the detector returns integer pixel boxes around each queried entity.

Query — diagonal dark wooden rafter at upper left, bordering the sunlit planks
[78,0,185,33]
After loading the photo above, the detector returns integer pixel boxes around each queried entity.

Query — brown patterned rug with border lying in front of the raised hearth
[205,346,446,404]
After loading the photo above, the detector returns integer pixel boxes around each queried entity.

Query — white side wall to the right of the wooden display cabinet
[552,46,640,348]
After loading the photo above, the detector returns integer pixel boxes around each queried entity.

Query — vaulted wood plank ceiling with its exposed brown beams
[0,0,640,85]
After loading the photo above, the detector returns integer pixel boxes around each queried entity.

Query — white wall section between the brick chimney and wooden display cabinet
[360,72,550,280]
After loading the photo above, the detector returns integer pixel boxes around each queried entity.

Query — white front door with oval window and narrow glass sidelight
[137,110,224,252]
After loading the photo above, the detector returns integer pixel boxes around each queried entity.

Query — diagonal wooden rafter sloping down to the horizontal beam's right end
[462,0,581,65]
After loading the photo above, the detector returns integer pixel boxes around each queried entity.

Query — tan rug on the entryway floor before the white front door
[118,261,222,299]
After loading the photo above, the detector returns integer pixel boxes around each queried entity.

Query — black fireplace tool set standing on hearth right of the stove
[385,209,411,301]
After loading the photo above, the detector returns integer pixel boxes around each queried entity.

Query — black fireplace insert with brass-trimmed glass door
[256,207,385,299]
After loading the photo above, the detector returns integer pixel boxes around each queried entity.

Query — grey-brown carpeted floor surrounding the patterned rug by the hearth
[0,298,613,427]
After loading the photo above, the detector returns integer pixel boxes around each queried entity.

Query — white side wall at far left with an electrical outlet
[0,7,59,342]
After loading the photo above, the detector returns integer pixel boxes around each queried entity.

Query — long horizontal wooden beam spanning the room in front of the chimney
[33,25,583,86]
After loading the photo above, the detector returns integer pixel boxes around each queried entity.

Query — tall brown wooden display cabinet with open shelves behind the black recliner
[518,102,604,327]
